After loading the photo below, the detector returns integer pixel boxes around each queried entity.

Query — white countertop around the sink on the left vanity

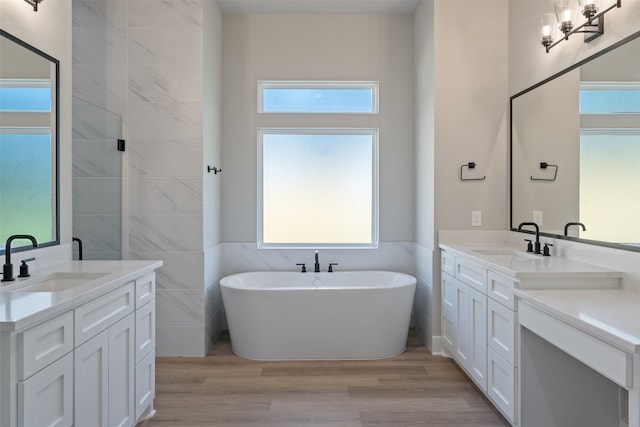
[0,261,162,331]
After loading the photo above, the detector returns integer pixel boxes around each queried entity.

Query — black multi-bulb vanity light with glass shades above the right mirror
[538,0,622,53]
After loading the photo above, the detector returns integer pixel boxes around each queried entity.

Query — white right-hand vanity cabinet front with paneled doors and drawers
[441,249,517,424]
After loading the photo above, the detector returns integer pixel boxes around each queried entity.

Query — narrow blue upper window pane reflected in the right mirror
[580,89,640,113]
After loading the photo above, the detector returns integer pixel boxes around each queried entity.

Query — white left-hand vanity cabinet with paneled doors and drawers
[0,261,161,427]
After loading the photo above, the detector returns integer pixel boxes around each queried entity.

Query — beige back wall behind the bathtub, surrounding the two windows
[222,15,415,273]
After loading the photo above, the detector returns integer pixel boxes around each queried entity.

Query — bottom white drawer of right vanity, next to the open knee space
[487,348,516,424]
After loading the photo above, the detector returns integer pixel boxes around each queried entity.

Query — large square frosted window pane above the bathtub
[262,131,377,245]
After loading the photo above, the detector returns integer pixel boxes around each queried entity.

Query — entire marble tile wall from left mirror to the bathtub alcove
[73,0,214,356]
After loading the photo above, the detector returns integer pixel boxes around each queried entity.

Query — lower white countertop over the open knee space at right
[514,289,640,354]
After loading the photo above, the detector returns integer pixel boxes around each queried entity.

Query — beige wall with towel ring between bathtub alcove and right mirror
[415,0,508,351]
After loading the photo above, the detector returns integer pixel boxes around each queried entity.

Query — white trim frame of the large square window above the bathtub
[256,127,379,249]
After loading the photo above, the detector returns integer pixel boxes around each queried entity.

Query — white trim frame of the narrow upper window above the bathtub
[258,80,380,115]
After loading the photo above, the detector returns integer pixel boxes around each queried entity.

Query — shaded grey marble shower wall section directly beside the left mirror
[72,0,127,259]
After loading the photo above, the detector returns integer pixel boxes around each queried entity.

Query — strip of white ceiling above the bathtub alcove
[217,0,422,15]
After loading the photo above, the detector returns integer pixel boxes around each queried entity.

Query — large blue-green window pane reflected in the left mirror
[0,133,55,246]
